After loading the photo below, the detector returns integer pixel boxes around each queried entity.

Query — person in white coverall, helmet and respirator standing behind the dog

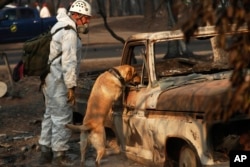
[39,0,91,166]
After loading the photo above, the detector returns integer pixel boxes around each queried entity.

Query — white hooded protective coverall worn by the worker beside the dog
[39,13,82,152]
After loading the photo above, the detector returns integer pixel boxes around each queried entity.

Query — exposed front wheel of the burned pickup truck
[179,145,200,167]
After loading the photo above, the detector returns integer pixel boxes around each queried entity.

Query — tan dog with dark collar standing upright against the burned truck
[66,65,140,166]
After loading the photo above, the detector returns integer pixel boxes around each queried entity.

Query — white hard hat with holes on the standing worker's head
[69,0,91,16]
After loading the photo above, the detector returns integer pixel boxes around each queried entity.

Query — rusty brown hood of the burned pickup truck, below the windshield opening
[156,71,231,112]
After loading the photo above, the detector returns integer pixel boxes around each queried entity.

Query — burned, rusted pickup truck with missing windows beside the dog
[76,26,250,167]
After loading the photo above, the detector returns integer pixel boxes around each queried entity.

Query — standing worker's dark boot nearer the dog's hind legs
[52,151,74,166]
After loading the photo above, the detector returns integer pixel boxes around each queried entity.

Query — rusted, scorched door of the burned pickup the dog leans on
[118,41,153,150]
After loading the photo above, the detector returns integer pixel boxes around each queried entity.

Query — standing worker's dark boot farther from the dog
[38,145,53,165]
